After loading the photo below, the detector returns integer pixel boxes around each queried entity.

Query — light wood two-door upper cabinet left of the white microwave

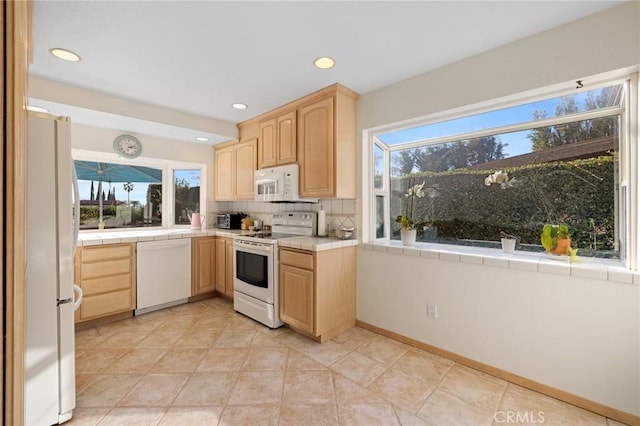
[214,139,258,201]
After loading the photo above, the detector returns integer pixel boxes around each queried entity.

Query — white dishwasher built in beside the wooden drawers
[135,238,191,315]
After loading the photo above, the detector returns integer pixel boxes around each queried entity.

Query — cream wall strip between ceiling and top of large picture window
[358,2,640,129]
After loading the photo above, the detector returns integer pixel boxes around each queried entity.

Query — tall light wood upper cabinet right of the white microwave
[298,86,357,198]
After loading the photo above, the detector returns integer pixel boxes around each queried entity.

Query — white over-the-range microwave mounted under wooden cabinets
[254,163,318,203]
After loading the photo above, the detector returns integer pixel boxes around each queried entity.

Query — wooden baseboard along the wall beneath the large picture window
[356,320,640,426]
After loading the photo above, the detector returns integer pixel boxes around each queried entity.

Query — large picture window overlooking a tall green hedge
[371,82,628,258]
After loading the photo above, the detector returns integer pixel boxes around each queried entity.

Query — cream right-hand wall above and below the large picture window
[358,2,640,415]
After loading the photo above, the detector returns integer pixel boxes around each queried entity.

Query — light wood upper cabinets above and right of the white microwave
[235,83,358,200]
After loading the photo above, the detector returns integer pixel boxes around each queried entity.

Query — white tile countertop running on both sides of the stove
[78,228,358,251]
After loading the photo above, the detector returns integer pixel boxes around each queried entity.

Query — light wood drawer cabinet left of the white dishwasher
[74,243,136,322]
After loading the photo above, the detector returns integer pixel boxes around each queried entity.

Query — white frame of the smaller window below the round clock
[71,149,207,233]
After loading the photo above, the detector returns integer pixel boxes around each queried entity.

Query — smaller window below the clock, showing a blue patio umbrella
[74,156,206,230]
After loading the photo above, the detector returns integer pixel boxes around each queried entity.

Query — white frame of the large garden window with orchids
[362,72,640,270]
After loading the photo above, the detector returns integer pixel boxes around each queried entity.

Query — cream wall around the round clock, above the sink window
[71,121,213,201]
